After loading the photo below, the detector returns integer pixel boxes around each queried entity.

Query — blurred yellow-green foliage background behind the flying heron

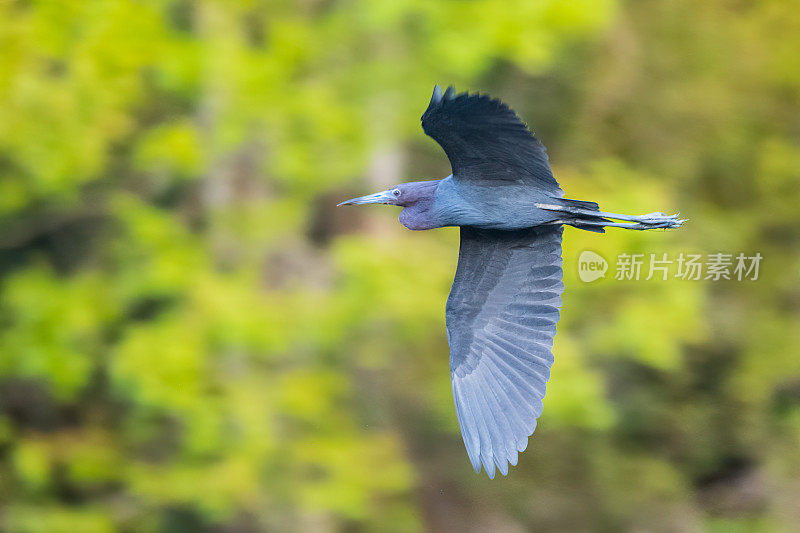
[0,0,800,532]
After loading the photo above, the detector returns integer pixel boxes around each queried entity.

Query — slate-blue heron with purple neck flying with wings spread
[339,85,684,478]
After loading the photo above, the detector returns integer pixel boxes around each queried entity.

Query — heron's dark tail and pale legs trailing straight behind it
[536,198,685,233]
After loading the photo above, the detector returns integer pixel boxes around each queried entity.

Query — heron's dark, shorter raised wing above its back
[422,85,561,196]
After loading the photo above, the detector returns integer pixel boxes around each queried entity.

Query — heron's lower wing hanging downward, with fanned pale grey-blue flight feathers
[447,226,564,478]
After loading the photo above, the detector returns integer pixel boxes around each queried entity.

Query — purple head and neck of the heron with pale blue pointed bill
[339,180,442,230]
